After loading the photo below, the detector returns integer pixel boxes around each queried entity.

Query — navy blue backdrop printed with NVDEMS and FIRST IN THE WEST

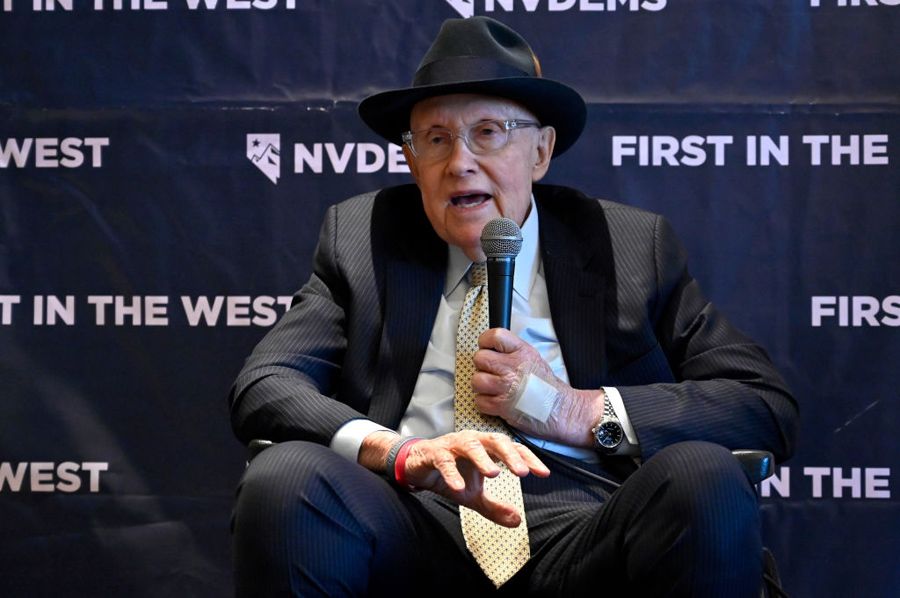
[0,0,900,597]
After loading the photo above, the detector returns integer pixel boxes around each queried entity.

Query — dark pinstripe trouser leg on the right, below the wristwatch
[503,442,762,598]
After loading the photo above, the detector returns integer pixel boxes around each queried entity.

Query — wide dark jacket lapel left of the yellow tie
[369,185,447,427]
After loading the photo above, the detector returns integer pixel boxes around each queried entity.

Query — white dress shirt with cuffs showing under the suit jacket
[331,198,637,461]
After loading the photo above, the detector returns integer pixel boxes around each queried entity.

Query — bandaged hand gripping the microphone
[472,328,603,447]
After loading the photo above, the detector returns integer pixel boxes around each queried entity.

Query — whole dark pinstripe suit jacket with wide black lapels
[231,185,797,459]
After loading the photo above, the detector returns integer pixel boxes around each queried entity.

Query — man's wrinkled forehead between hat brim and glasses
[409,94,536,130]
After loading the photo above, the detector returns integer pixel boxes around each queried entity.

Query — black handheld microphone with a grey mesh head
[481,218,522,330]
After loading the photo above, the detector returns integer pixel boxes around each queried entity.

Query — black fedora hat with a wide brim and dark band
[359,17,587,156]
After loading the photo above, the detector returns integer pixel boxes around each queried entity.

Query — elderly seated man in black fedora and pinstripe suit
[231,17,797,597]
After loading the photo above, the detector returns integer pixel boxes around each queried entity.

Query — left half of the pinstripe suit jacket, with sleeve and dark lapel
[230,187,447,444]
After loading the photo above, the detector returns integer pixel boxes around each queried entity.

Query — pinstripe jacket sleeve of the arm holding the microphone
[617,216,798,461]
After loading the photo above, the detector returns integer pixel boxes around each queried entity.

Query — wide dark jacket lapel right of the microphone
[534,185,617,389]
